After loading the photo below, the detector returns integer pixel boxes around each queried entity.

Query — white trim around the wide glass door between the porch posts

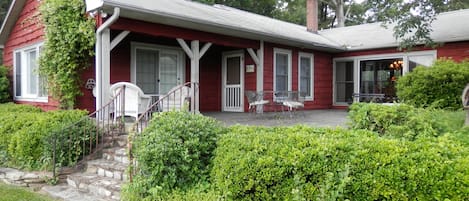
[130,42,186,93]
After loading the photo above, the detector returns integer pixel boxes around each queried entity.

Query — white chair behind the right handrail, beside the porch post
[159,86,191,112]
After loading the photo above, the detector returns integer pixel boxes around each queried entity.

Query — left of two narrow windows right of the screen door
[274,49,291,91]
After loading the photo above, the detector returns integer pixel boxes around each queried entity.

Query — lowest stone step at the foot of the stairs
[67,172,122,200]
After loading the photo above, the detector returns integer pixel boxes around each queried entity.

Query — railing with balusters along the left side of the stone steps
[51,86,125,179]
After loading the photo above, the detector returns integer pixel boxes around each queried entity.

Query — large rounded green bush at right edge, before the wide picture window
[396,60,469,110]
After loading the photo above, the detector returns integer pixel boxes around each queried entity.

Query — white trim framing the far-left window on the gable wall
[12,42,49,103]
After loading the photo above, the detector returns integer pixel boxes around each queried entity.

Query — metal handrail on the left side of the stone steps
[52,86,125,178]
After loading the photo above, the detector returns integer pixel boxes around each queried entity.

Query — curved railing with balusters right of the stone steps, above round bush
[128,82,199,182]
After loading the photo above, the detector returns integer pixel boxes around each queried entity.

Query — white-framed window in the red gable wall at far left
[14,45,47,102]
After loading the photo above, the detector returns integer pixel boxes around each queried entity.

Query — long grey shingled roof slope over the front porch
[98,0,345,52]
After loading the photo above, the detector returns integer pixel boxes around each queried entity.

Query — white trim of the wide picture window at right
[332,50,438,106]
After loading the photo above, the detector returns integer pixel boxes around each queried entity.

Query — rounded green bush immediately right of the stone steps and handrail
[123,112,223,200]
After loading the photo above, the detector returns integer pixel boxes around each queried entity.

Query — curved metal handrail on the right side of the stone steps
[127,82,199,182]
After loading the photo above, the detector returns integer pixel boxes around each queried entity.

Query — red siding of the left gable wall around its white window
[3,0,59,110]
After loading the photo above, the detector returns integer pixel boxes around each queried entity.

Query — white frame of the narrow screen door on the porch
[221,50,244,112]
